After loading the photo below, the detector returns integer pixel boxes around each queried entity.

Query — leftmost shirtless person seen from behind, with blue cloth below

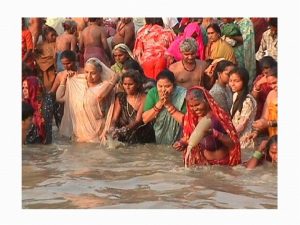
[55,20,77,72]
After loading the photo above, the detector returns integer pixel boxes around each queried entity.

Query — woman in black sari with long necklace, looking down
[110,70,155,144]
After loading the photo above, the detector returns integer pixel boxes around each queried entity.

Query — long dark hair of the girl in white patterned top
[229,67,249,117]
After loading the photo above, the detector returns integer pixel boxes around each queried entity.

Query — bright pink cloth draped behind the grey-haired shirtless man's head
[166,22,205,61]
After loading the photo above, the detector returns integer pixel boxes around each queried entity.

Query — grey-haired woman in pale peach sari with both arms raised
[56,58,119,143]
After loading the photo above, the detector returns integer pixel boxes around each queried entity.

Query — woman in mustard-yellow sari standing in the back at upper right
[205,23,236,64]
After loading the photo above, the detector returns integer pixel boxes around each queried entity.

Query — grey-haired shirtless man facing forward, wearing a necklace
[169,38,212,89]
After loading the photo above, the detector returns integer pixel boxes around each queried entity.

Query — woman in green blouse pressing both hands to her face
[142,69,186,144]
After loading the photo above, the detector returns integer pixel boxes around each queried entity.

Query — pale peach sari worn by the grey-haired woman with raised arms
[56,63,115,144]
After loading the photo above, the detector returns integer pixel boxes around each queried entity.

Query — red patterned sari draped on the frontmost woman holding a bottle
[183,86,241,166]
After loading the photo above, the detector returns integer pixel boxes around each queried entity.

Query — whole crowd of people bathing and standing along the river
[22,18,278,169]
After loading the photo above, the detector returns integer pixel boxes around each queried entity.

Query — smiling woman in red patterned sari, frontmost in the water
[173,86,241,166]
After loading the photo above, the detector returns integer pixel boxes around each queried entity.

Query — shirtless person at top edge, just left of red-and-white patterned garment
[111,18,135,50]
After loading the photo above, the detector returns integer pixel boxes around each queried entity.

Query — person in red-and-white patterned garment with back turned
[133,18,175,80]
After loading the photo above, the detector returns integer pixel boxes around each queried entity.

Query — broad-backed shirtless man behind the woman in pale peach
[79,18,111,67]
